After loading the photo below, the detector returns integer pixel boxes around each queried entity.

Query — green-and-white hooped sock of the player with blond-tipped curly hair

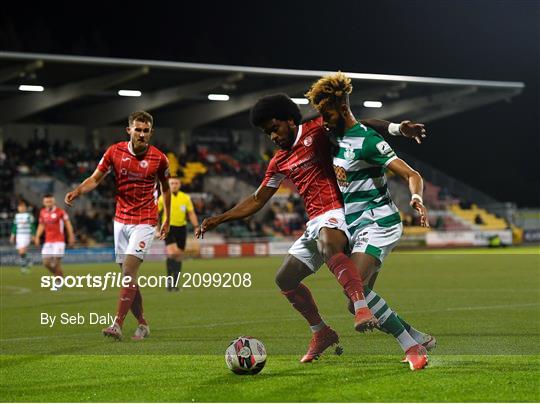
[364,287,417,351]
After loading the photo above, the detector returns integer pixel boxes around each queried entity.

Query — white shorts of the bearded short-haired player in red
[114,220,156,264]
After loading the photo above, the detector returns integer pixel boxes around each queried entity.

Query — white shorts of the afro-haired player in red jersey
[289,209,350,272]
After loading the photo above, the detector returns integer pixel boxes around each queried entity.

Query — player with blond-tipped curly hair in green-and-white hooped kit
[306,73,436,370]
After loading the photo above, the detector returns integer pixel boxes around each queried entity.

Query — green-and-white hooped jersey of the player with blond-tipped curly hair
[334,123,401,236]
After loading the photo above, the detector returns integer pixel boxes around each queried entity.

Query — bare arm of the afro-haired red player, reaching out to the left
[195,185,278,238]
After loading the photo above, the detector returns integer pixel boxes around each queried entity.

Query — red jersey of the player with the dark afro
[262,117,343,220]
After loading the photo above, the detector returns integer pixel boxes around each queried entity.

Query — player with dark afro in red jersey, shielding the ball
[198,94,404,362]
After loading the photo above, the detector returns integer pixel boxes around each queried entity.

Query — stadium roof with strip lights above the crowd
[0,52,525,129]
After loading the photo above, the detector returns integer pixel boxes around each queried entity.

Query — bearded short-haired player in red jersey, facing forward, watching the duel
[65,111,171,340]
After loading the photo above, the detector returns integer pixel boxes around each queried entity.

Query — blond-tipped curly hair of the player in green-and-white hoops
[305,72,352,112]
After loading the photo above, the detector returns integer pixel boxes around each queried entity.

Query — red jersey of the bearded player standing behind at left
[98,142,169,226]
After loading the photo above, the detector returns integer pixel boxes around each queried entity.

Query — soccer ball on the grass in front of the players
[225,337,266,375]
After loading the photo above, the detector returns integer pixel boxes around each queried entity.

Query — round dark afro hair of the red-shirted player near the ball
[250,94,302,127]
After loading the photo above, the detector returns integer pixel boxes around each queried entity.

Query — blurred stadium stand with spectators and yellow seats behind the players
[0,136,519,246]
